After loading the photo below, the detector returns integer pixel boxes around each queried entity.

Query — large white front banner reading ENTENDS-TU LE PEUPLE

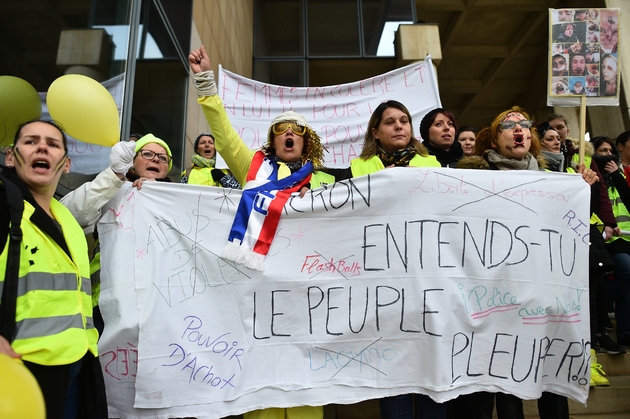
[98,168,590,418]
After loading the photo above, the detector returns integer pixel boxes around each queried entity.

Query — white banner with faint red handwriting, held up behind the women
[217,57,441,168]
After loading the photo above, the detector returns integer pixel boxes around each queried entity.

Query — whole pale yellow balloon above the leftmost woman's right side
[46,74,120,147]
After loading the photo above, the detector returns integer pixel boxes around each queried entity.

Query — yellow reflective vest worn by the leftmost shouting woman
[0,199,98,365]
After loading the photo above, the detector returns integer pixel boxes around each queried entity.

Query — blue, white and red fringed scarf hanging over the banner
[221,150,313,272]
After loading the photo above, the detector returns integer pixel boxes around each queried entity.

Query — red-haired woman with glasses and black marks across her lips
[451,106,598,419]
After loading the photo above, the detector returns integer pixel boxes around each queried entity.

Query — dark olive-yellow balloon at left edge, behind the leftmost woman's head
[0,76,42,146]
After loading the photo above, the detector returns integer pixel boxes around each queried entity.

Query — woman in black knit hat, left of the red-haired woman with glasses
[420,108,463,167]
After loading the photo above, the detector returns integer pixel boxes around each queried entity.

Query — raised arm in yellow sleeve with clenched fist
[188,45,253,185]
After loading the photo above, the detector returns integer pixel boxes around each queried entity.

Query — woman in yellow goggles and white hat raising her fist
[188,46,335,419]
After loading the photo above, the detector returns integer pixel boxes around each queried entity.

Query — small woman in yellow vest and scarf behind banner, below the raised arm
[181,132,241,189]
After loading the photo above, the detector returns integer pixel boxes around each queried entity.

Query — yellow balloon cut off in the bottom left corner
[0,354,46,419]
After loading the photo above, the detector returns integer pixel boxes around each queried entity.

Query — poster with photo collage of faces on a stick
[547,9,621,106]
